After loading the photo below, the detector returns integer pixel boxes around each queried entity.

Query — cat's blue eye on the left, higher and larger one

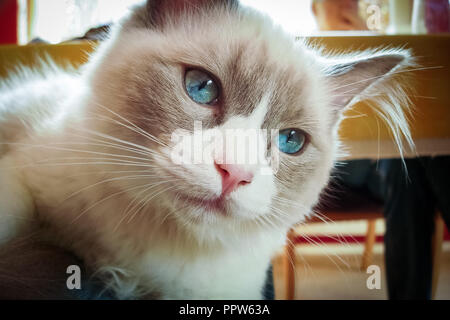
[184,69,219,104]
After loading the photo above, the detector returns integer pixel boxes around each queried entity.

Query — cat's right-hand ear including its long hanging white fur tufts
[325,50,416,154]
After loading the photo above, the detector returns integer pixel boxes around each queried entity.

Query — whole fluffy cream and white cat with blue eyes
[0,0,411,299]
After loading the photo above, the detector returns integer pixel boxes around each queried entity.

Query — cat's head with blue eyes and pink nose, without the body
[87,1,412,240]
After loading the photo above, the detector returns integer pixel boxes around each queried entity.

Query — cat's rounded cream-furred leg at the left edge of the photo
[0,158,34,244]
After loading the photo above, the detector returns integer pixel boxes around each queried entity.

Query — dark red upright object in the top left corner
[0,0,19,44]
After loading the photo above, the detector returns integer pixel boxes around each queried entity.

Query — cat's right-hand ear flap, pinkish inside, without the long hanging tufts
[324,50,413,110]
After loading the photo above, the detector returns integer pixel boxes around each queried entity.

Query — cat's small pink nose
[216,163,253,196]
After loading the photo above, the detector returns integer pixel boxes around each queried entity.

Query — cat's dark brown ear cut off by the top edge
[147,0,237,28]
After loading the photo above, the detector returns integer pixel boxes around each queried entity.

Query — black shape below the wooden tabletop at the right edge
[336,157,450,300]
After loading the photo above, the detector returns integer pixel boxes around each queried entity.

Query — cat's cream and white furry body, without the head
[0,75,284,299]
